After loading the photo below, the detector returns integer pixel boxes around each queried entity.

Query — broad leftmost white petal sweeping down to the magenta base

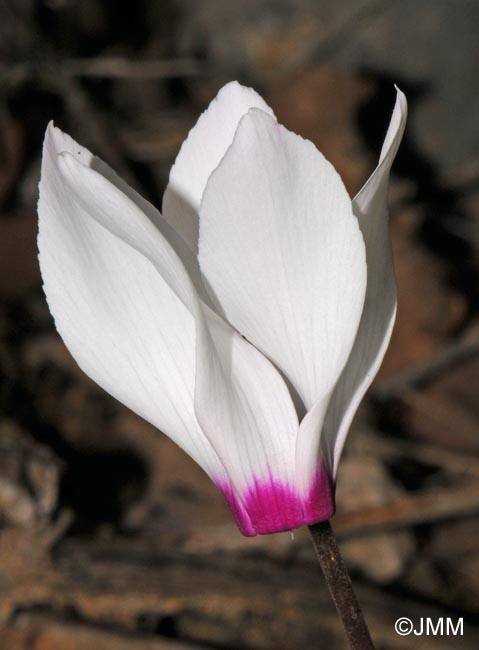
[40,124,298,534]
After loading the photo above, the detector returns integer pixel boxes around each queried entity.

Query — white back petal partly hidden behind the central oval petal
[163,81,273,253]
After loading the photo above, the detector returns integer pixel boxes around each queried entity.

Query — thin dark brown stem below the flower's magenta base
[308,521,374,650]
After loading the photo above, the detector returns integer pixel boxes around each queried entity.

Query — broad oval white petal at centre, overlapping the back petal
[199,109,366,496]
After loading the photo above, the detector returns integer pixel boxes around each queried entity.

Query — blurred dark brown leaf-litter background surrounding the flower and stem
[0,0,479,650]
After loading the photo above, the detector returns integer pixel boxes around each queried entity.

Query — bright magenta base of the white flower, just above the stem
[219,467,335,537]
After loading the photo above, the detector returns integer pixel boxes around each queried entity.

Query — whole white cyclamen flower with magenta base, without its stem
[38,82,406,535]
